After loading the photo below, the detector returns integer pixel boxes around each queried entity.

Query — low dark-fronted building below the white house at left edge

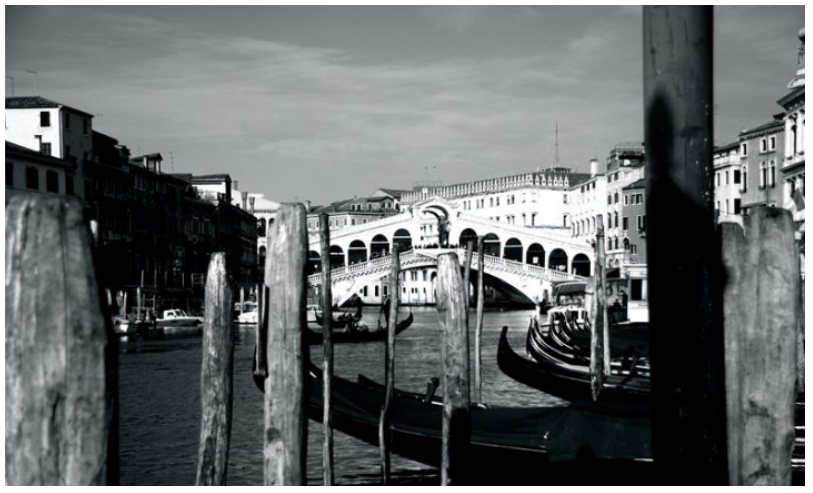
[6,141,77,199]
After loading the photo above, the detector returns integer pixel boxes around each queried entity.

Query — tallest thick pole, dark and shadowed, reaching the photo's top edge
[643,5,727,485]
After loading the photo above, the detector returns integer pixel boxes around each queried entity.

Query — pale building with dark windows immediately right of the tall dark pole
[714,141,747,221]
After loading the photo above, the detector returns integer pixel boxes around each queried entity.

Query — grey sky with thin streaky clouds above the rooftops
[5,5,805,204]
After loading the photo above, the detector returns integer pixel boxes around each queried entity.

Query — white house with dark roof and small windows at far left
[6,96,93,198]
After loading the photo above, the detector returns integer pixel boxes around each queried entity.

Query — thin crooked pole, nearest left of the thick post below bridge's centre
[378,245,401,486]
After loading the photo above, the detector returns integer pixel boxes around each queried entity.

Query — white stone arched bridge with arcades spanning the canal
[308,197,594,304]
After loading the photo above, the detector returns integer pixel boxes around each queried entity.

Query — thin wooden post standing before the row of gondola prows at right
[588,214,610,401]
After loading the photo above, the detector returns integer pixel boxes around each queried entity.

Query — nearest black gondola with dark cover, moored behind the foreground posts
[308,367,656,484]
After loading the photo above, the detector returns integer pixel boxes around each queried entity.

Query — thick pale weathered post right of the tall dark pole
[720,207,801,486]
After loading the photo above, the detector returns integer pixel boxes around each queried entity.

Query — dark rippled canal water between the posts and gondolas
[119,307,562,486]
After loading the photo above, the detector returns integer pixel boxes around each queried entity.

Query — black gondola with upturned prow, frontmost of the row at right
[497,327,650,402]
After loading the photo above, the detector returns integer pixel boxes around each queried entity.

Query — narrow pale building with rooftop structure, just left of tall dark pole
[604,142,646,267]
